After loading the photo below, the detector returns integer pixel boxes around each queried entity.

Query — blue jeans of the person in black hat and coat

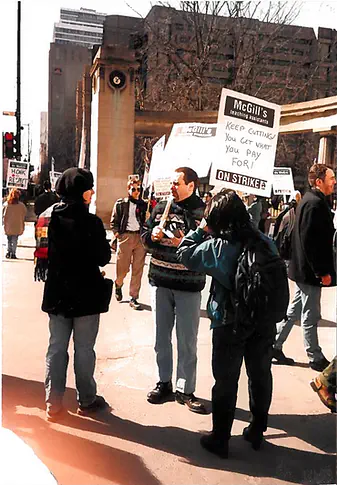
[45,314,100,411]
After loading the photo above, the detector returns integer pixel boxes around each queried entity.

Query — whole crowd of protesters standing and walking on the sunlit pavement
[4,164,336,458]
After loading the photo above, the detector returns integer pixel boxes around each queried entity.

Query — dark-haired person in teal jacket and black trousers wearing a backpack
[177,189,289,458]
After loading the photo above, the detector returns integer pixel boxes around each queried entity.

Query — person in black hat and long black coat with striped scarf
[42,168,111,421]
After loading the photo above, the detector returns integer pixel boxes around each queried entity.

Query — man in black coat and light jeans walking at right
[275,163,336,372]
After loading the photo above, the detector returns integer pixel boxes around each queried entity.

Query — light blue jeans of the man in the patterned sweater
[151,286,201,394]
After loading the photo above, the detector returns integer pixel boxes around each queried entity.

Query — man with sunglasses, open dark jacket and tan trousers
[110,176,146,310]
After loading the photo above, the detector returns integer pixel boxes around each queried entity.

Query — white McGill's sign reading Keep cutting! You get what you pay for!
[209,89,281,197]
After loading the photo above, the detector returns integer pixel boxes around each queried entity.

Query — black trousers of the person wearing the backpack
[212,323,276,441]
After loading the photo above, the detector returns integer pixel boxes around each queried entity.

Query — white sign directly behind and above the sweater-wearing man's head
[164,123,217,178]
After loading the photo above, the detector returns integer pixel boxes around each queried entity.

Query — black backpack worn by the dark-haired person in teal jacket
[231,237,289,327]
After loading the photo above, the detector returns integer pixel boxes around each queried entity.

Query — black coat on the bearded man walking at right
[289,189,336,286]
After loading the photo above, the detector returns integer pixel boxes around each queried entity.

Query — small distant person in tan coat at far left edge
[3,188,27,259]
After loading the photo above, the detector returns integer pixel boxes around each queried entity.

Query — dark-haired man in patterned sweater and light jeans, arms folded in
[142,167,207,414]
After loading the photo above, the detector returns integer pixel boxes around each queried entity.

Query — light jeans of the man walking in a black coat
[275,283,324,362]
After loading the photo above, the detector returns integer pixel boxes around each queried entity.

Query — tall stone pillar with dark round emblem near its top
[90,45,137,225]
